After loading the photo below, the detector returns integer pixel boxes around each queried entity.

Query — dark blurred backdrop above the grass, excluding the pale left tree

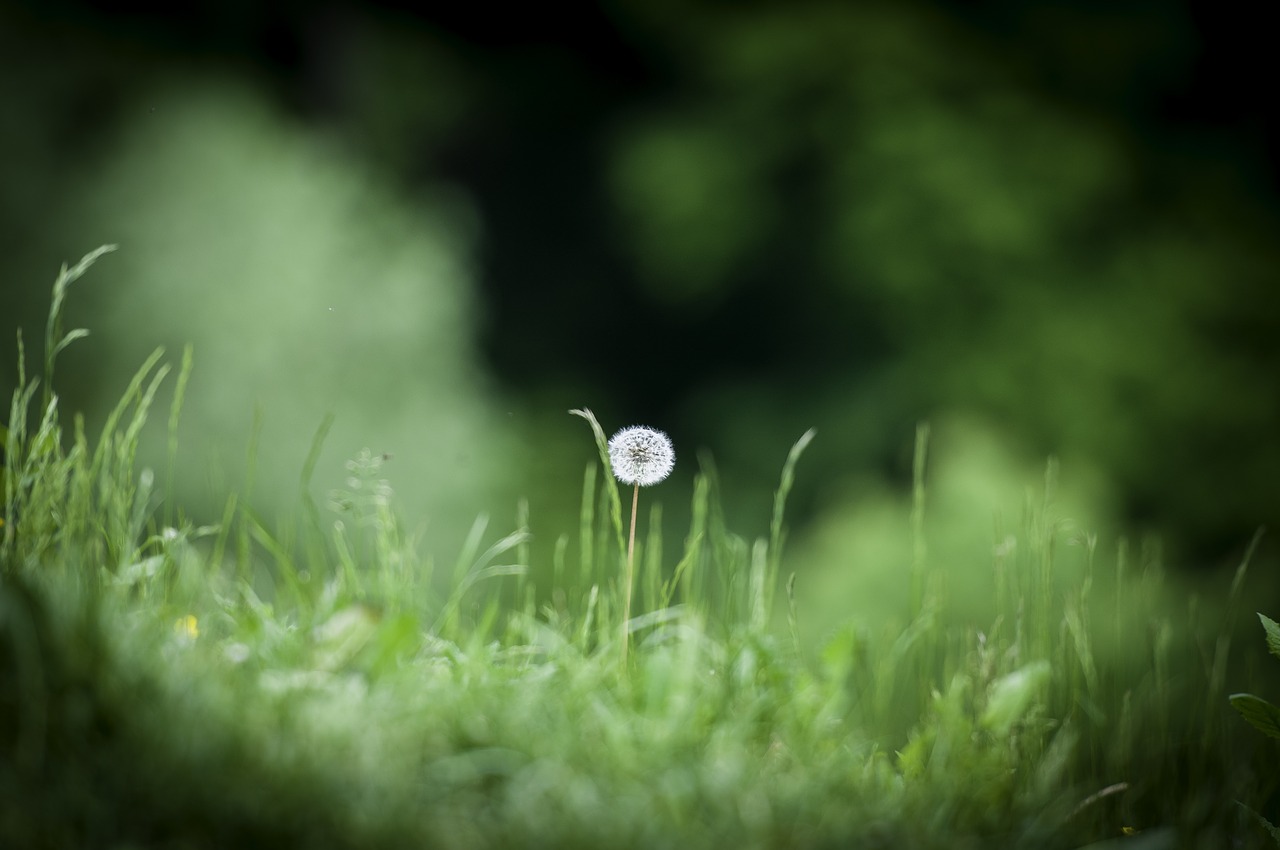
[0,1,1280,611]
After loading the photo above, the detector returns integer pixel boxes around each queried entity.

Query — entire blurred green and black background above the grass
[0,0,1280,629]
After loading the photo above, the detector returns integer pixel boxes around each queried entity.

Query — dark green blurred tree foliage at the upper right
[593,4,1280,563]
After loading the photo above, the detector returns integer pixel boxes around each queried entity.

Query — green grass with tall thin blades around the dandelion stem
[0,252,1276,850]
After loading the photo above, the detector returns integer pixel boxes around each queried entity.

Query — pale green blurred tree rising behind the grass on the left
[63,79,509,557]
